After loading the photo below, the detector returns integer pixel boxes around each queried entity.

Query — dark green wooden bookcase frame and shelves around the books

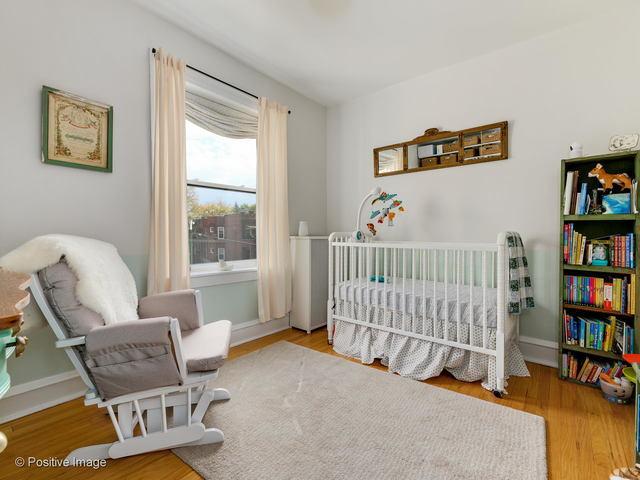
[558,151,640,388]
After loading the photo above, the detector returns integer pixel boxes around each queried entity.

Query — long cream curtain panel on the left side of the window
[147,49,189,295]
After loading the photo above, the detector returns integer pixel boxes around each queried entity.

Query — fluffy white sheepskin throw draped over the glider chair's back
[0,235,138,325]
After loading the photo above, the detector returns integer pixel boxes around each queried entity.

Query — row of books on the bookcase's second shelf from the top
[563,223,635,268]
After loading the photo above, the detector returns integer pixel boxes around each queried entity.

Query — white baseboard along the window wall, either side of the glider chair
[0,316,289,423]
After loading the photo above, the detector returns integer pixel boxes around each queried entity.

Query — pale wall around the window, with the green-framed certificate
[0,0,326,383]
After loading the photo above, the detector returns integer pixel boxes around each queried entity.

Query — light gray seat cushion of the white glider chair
[182,320,231,372]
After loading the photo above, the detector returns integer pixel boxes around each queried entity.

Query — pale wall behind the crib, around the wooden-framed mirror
[327,7,640,340]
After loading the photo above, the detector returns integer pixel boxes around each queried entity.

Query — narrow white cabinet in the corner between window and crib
[290,236,329,333]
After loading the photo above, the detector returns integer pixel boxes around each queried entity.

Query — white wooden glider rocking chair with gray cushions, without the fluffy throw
[30,261,231,460]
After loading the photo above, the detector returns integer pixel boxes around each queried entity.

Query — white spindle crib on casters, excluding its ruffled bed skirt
[327,232,526,397]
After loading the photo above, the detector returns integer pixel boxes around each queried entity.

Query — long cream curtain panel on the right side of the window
[256,98,291,322]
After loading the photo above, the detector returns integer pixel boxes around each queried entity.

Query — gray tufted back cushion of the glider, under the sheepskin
[38,257,104,337]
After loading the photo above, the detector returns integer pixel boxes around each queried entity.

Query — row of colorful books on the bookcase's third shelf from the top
[564,274,636,314]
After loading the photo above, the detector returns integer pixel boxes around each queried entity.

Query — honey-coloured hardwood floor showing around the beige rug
[0,329,633,480]
